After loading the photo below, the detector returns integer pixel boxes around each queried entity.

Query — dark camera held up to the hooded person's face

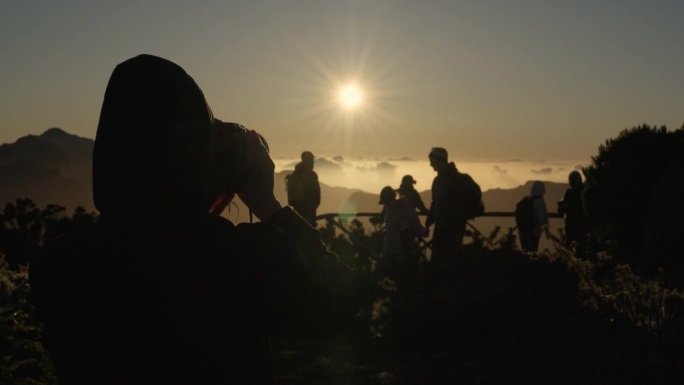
[210,119,269,214]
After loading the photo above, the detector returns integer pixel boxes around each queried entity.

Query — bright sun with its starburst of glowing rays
[274,30,415,154]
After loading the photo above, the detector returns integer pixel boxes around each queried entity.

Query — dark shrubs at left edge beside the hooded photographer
[0,199,96,384]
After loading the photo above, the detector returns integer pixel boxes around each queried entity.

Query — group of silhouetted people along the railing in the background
[285,142,587,286]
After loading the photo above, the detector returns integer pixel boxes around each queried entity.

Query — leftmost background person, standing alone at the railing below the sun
[285,151,321,227]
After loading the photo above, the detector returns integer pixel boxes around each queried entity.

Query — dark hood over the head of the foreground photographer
[93,55,213,216]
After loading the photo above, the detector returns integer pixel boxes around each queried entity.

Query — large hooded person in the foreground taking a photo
[29,55,334,385]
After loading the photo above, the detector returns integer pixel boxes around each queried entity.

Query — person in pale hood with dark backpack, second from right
[515,181,549,252]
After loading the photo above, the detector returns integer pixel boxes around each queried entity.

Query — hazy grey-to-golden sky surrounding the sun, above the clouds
[0,0,684,161]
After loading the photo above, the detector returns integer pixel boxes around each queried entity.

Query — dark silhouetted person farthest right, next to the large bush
[558,171,587,257]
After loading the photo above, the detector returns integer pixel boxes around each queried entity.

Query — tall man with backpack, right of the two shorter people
[425,147,484,267]
